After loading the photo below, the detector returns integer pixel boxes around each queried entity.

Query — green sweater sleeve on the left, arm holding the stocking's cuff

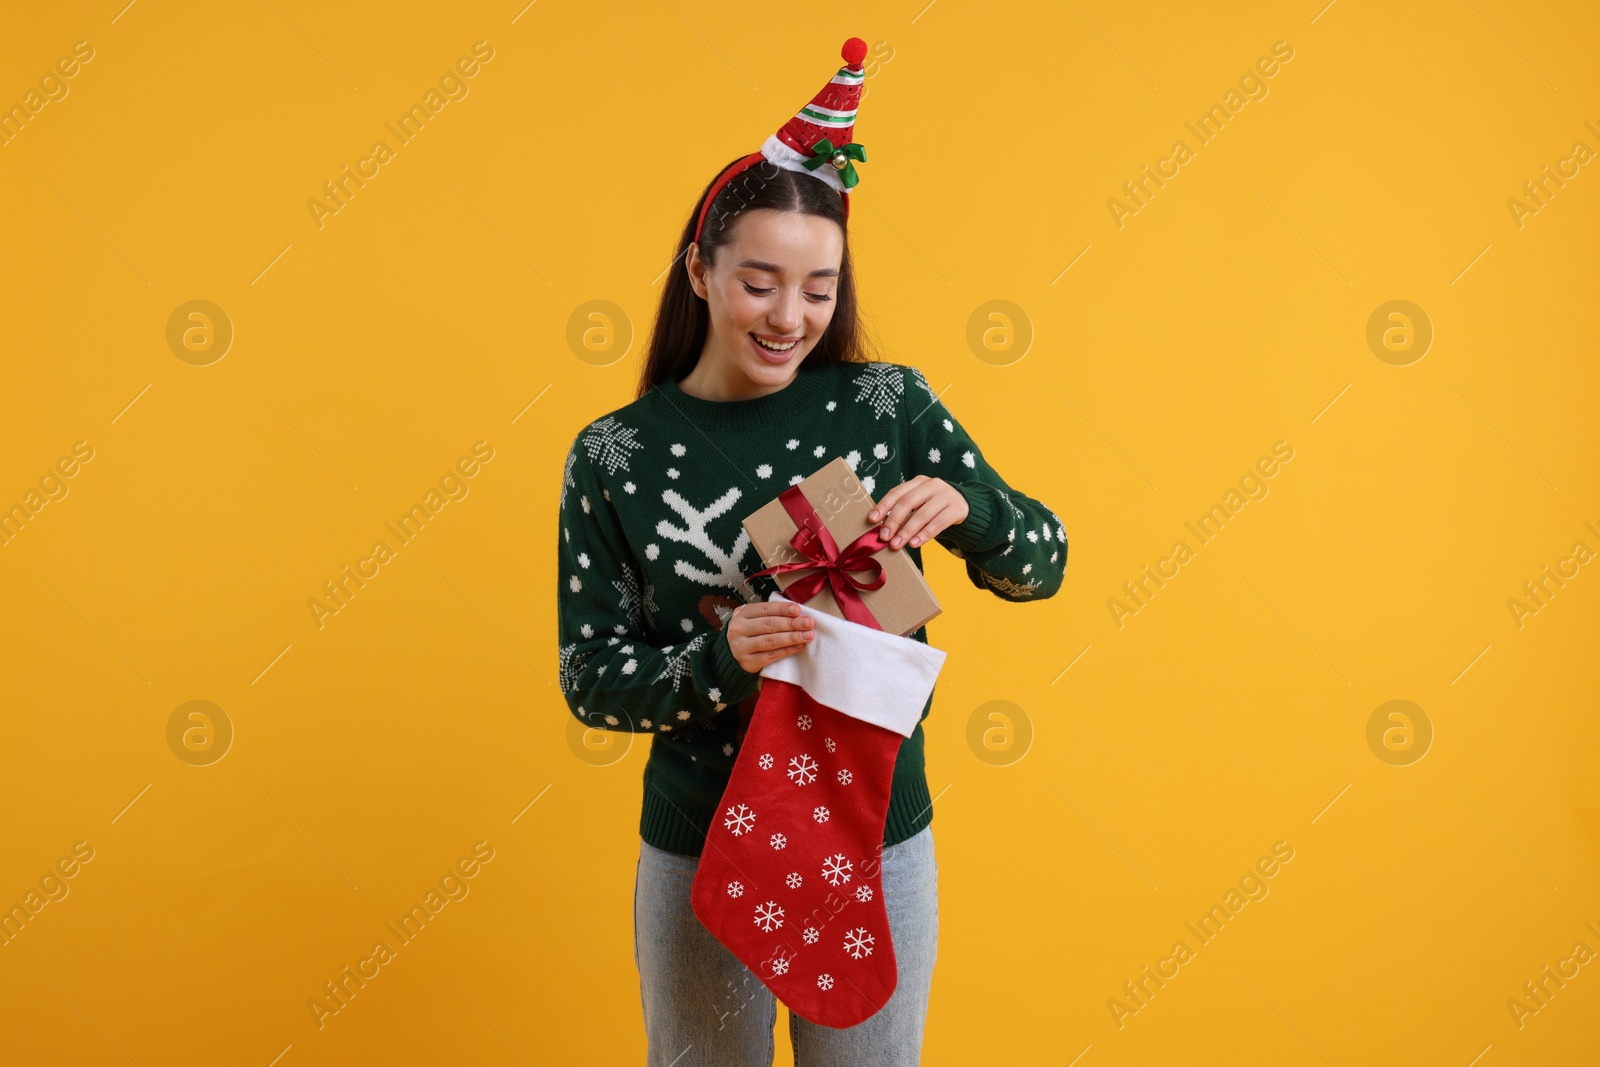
[555,435,760,737]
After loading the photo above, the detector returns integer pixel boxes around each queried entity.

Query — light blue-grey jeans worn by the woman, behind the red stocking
[634,825,939,1067]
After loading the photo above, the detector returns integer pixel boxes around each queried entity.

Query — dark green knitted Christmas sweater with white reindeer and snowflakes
[557,362,1067,856]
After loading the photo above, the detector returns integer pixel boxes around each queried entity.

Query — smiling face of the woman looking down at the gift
[688,208,845,389]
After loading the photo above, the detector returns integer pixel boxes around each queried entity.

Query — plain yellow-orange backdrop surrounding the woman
[0,0,1600,1067]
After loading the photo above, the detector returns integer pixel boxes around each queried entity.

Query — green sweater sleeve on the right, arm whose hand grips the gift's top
[906,366,1067,601]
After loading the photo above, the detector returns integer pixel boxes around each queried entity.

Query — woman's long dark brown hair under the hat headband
[638,157,867,404]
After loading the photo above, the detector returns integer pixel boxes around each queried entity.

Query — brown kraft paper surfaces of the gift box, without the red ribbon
[744,456,941,637]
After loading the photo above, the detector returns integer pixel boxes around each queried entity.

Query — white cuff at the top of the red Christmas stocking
[760,592,944,737]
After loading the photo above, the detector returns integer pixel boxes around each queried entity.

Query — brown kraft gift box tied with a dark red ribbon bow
[744,456,941,637]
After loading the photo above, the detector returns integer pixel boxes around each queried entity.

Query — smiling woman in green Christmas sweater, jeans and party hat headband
[557,38,1067,1067]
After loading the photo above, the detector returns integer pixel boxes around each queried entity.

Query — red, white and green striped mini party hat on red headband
[694,37,867,240]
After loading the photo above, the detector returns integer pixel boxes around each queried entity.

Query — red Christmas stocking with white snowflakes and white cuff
[691,592,944,1027]
